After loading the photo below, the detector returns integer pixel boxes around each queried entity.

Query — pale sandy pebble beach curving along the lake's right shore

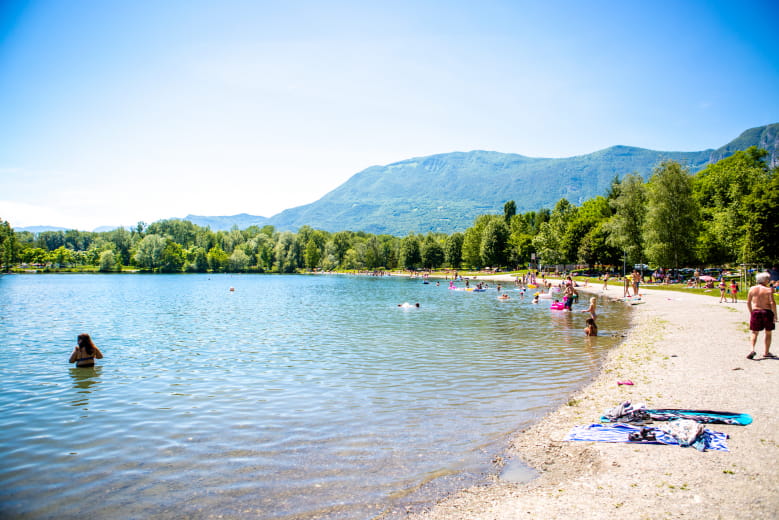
[409,277,779,520]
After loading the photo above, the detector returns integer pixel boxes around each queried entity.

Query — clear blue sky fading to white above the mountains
[0,0,779,231]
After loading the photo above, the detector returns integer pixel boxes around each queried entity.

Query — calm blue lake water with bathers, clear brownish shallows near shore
[0,274,628,520]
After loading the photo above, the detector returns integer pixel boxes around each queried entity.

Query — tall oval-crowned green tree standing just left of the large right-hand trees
[644,161,700,268]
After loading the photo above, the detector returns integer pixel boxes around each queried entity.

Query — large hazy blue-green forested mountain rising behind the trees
[251,123,779,236]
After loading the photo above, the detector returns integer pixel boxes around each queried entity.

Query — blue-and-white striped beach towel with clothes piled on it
[563,420,730,451]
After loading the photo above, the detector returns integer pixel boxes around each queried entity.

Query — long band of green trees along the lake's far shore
[0,147,779,273]
